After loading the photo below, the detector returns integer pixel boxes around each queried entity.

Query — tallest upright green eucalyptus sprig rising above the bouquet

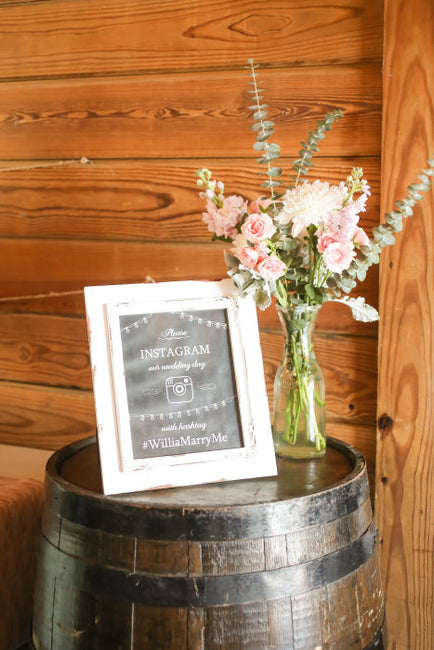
[246,59,282,205]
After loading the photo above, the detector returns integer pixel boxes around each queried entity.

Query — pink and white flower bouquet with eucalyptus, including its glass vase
[197,59,434,458]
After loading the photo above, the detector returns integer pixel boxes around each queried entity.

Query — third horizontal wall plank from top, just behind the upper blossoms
[0,157,380,242]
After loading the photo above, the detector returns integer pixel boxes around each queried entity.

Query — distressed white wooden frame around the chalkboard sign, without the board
[84,280,277,494]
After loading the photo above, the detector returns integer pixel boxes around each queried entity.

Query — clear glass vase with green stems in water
[273,304,326,459]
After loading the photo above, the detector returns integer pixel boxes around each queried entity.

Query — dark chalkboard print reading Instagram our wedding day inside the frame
[119,309,243,460]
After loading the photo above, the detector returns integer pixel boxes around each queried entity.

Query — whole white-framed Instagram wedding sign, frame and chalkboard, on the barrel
[84,279,277,494]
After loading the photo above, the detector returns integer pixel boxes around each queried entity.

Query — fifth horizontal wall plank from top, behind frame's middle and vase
[0,314,376,423]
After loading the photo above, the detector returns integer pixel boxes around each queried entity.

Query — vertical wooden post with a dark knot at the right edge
[376,0,434,650]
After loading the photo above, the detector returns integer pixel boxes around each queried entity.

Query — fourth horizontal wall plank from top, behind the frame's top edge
[0,239,378,326]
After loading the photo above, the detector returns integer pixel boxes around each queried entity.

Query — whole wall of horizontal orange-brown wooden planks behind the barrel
[0,0,382,480]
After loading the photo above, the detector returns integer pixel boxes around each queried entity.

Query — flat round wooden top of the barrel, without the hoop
[55,438,356,508]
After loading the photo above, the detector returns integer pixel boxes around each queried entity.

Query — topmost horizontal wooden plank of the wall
[0,0,382,78]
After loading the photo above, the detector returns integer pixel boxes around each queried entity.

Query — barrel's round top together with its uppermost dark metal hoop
[45,438,369,540]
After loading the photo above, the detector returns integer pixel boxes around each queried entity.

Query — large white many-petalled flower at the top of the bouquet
[277,180,347,237]
